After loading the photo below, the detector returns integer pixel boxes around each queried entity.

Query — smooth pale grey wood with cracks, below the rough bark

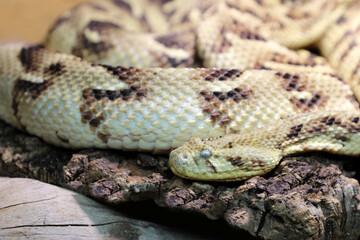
[0,177,236,240]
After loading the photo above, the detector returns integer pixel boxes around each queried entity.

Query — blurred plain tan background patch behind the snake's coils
[0,0,88,42]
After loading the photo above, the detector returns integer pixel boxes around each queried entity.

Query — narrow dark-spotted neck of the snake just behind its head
[274,112,360,157]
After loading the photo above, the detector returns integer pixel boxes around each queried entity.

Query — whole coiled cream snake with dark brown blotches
[0,0,360,181]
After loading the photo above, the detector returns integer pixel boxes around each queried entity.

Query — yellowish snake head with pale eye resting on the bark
[169,137,281,181]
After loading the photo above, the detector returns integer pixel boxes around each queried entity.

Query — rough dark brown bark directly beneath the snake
[0,122,360,239]
